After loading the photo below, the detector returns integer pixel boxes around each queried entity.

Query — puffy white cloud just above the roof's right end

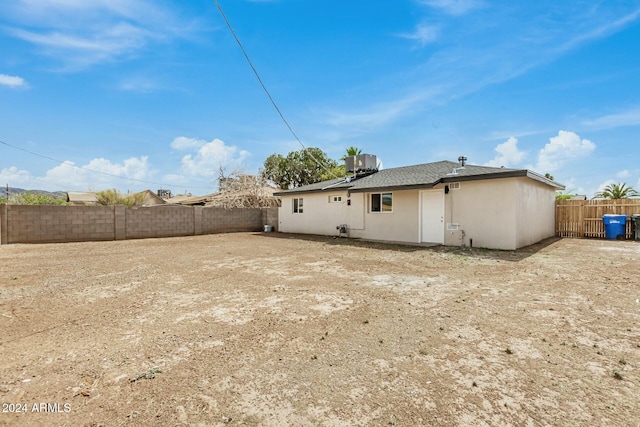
[536,130,596,173]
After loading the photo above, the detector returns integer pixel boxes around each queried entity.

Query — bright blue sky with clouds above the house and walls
[0,0,640,197]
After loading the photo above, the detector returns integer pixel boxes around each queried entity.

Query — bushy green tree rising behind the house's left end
[261,147,344,190]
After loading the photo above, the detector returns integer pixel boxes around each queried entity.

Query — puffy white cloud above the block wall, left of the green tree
[171,136,250,177]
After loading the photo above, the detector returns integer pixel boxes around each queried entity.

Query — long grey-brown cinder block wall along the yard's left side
[0,204,278,244]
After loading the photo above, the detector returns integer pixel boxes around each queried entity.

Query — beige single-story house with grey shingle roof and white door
[274,155,564,250]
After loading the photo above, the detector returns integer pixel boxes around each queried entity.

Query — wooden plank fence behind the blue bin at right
[556,199,640,239]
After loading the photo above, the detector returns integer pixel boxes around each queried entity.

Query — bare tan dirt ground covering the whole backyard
[0,233,640,427]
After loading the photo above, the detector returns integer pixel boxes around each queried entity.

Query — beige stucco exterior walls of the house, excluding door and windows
[279,177,555,250]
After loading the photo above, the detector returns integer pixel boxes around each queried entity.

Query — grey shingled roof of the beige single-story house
[274,160,564,196]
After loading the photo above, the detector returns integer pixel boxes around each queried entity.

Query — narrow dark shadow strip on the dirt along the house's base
[255,233,561,262]
